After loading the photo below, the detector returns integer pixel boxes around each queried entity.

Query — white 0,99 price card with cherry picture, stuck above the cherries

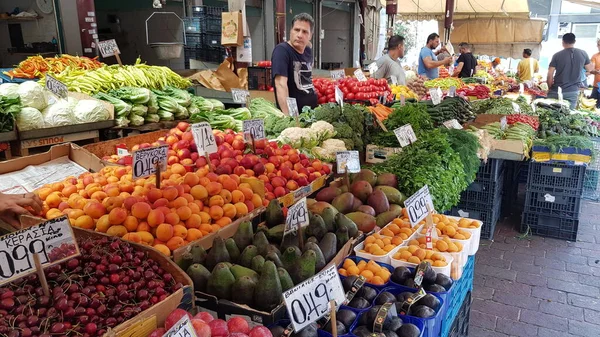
[0,216,79,285]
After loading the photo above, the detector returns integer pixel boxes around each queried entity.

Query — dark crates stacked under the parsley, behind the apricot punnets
[450,159,504,240]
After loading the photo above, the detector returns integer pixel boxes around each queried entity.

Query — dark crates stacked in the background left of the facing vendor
[184,6,226,68]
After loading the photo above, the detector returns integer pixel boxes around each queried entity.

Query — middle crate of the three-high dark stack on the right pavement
[525,191,581,219]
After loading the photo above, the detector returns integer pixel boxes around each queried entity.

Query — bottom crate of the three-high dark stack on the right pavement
[521,212,579,241]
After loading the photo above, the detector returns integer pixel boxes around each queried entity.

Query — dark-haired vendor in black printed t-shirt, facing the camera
[271,13,317,115]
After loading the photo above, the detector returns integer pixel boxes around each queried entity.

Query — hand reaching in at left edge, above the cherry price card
[0,193,42,229]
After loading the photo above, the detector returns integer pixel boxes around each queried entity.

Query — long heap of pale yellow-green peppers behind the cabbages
[40,59,191,95]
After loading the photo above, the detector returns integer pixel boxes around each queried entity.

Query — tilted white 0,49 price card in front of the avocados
[283,265,346,332]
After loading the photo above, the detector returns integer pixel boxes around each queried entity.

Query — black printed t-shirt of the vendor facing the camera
[271,42,317,111]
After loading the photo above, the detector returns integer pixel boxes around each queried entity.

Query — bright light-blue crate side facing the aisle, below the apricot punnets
[440,256,475,336]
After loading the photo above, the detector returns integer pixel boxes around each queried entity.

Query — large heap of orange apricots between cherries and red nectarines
[35,164,268,255]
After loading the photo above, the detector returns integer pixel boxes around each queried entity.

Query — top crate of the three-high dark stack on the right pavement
[527,162,585,193]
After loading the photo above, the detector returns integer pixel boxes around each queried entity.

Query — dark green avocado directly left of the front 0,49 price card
[254,261,282,312]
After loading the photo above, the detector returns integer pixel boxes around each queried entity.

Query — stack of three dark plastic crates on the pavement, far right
[521,162,586,241]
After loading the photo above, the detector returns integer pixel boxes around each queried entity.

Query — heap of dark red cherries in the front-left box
[0,238,182,337]
